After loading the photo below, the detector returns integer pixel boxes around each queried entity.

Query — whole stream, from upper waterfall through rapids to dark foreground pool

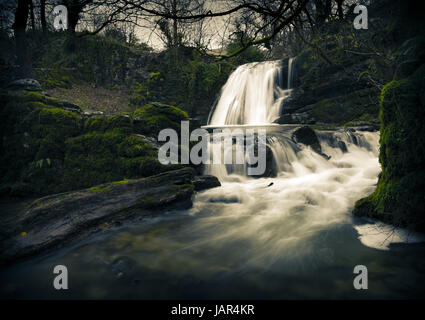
[0,62,425,299]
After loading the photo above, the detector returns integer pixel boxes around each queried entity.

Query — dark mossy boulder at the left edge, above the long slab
[0,92,81,195]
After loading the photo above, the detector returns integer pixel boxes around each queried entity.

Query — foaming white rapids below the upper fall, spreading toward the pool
[200,129,389,255]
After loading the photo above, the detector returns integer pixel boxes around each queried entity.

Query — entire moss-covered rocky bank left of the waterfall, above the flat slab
[1,92,187,195]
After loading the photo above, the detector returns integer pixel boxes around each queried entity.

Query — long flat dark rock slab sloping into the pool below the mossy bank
[0,168,199,263]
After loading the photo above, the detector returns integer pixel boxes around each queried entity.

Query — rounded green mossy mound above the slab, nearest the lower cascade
[62,131,165,188]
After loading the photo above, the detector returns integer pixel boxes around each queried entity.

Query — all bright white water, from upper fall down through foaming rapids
[201,59,414,252]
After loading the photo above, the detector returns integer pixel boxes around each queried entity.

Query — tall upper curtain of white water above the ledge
[208,59,294,126]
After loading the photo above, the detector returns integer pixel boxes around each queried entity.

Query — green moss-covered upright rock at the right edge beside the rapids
[354,65,425,231]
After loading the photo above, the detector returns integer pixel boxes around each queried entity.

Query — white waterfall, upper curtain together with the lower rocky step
[204,58,378,182]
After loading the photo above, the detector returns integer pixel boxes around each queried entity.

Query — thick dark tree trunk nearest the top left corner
[13,0,31,78]
